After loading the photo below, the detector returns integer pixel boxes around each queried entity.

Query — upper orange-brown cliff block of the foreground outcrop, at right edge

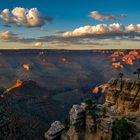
[106,79,140,113]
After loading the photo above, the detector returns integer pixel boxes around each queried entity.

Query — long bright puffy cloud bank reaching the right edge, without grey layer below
[63,23,140,37]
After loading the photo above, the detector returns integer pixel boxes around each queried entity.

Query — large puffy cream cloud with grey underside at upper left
[0,7,52,27]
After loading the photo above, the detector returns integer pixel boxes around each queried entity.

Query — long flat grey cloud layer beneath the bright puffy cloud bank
[10,32,140,46]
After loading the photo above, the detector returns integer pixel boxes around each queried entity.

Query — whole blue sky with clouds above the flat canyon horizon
[0,0,140,50]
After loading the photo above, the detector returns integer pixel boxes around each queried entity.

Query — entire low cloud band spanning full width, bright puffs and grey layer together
[0,23,140,48]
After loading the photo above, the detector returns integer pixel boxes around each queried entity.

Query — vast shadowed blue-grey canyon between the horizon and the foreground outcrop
[0,50,140,140]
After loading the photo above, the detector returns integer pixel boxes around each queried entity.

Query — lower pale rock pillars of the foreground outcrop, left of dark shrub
[45,103,112,140]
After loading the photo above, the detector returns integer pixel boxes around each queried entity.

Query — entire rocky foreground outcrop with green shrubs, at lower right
[45,79,140,140]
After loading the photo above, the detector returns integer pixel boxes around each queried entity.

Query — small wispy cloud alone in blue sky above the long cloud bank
[90,11,117,21]
